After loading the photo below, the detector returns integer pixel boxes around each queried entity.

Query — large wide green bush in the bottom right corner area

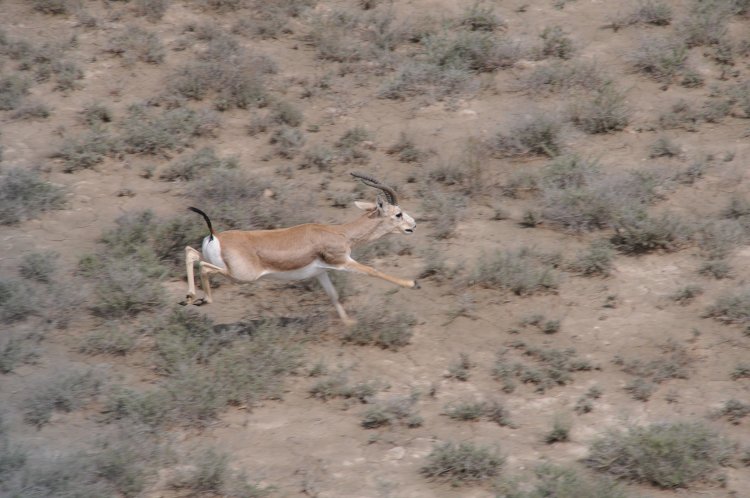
[586,422,731,488]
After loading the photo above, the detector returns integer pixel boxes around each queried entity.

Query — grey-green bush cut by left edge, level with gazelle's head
[0,167,65,225]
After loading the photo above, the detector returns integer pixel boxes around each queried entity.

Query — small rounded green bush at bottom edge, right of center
[420,442,505,486]
